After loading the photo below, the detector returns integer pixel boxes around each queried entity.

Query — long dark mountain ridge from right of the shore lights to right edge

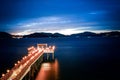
[23,31,120,38]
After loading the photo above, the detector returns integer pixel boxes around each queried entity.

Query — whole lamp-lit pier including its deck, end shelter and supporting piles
[0,44,55,80]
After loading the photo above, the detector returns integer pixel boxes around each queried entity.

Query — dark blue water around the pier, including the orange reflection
[0,38,120,80]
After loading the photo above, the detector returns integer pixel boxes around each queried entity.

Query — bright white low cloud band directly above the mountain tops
[12,27,91,35]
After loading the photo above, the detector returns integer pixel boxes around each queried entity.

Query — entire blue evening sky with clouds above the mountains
[0,0,120,35]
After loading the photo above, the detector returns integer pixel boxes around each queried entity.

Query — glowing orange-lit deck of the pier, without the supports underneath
[0,45,55,80]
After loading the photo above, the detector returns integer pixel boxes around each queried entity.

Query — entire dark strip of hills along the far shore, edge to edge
[0,31,120,39]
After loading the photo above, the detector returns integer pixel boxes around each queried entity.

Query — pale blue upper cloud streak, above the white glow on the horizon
[20,17,71,27]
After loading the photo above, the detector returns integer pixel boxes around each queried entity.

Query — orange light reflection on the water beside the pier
[36,59,59,80]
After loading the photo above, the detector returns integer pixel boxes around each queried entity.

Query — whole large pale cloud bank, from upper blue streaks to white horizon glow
[12,16,116,35]
